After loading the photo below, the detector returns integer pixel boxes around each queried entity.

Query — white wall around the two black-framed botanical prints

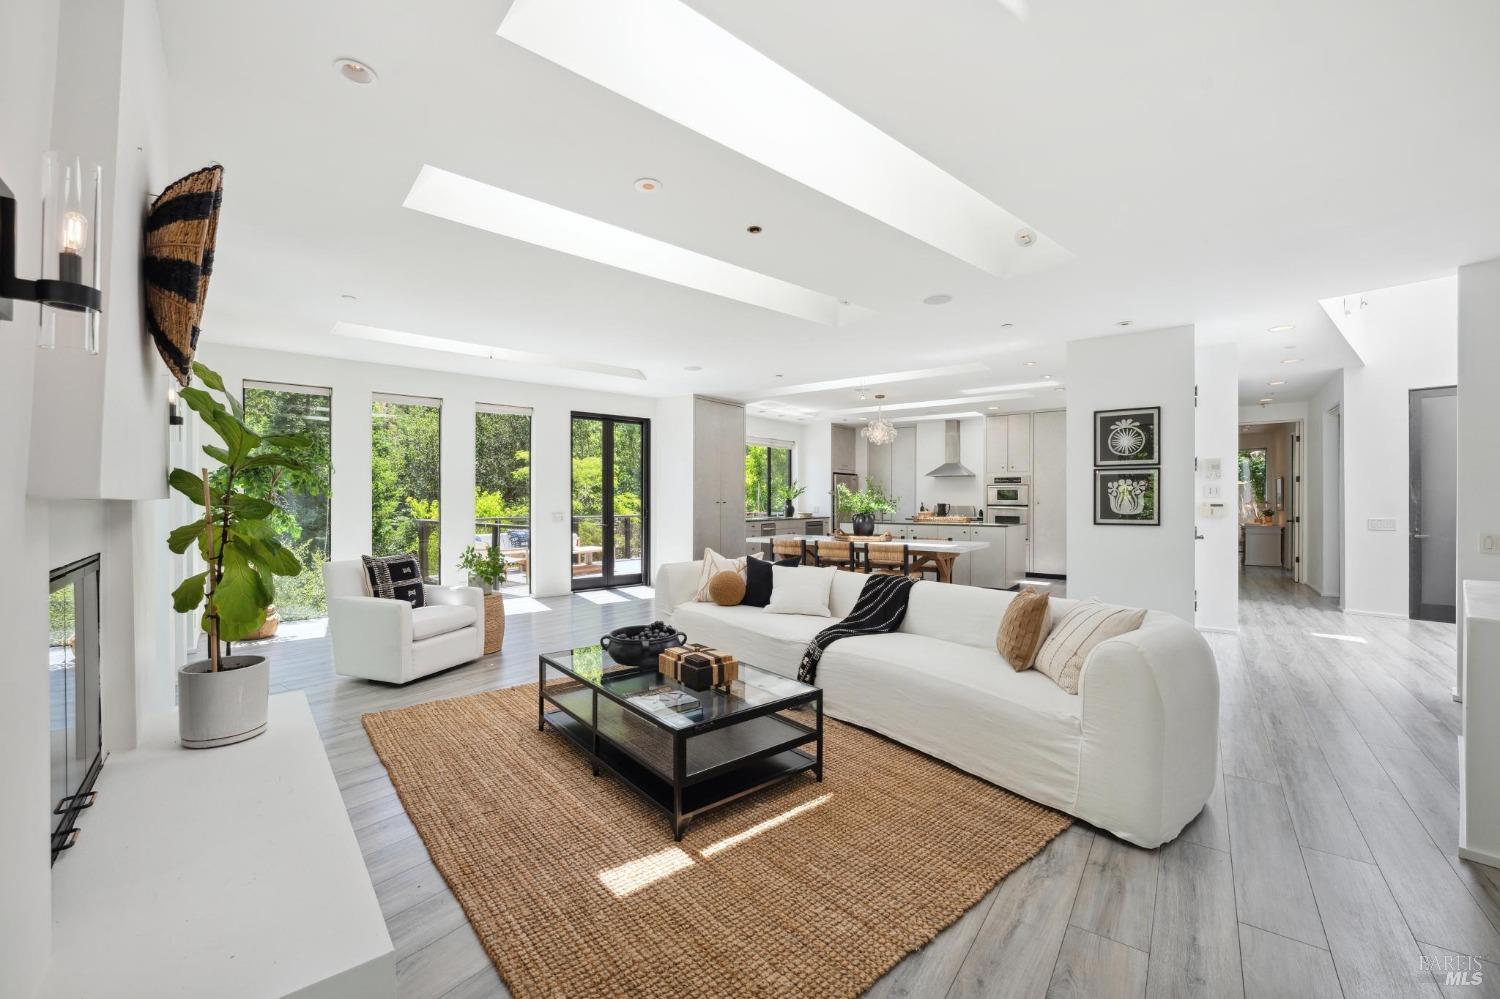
[1068,327,1196,621]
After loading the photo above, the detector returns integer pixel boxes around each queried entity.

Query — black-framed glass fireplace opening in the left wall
[47,555,104,864]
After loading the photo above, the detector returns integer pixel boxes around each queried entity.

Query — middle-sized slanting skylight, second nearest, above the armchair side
[402,165,873,326]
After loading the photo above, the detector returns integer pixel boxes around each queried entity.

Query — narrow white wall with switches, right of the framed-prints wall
[1188,344,1239,632]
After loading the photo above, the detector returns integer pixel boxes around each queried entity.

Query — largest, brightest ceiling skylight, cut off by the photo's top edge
[497,0,1070,276]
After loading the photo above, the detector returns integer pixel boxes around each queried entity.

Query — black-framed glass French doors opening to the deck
[570,413,651,590]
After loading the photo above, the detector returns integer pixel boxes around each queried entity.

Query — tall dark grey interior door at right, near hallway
[1409,386,1458,621]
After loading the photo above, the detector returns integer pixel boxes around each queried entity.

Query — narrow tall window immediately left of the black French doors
[474,402,531,593]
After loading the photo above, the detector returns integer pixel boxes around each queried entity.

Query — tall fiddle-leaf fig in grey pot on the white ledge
[167,363,314,749]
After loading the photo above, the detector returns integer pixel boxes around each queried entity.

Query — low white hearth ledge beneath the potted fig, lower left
[41,692,396,999]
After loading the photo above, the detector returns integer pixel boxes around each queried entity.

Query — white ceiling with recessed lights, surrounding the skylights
[159,0,1500,416]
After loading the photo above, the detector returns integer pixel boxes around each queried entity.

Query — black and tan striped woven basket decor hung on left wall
[144,165,224,386]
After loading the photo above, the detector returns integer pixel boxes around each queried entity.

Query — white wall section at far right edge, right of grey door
[1457,260,1500,690]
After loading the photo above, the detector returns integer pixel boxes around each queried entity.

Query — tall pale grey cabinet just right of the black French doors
[693,399,747,557]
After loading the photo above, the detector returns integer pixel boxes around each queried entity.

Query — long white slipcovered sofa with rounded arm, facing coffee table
[654,563,1218,848]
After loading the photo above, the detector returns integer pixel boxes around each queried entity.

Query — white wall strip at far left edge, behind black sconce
[0,0,59,999]
